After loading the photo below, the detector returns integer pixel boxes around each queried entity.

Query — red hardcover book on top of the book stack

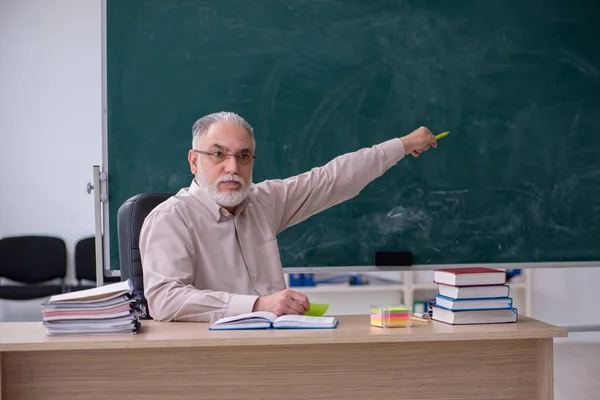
[433,267,506,286]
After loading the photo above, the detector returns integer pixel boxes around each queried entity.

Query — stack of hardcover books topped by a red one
[431,267,518,325]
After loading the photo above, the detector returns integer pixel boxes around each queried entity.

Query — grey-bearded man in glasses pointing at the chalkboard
[140,112,437,321]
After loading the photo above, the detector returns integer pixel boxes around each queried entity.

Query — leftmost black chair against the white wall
[0,236,67,300]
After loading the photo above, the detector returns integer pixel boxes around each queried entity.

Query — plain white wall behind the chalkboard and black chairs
[0,0,600,340]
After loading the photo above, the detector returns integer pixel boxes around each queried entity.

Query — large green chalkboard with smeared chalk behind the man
[106,0,600,268]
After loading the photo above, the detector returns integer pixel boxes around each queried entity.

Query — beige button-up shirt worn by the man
[140,139,404,321]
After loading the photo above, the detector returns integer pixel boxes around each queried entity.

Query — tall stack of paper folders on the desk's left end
[42,280,141,336]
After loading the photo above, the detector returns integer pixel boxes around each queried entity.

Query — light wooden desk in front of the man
[0,315,567,400]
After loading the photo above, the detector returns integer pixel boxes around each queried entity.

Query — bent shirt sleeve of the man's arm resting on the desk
[139,209,258,322]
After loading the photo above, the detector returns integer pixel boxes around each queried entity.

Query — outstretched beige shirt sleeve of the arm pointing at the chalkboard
[257,139,405,234]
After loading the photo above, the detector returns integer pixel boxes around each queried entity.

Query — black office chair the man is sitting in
[117,193,173,318]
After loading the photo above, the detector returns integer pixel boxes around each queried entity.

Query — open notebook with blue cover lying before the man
[208,311,338,330]
